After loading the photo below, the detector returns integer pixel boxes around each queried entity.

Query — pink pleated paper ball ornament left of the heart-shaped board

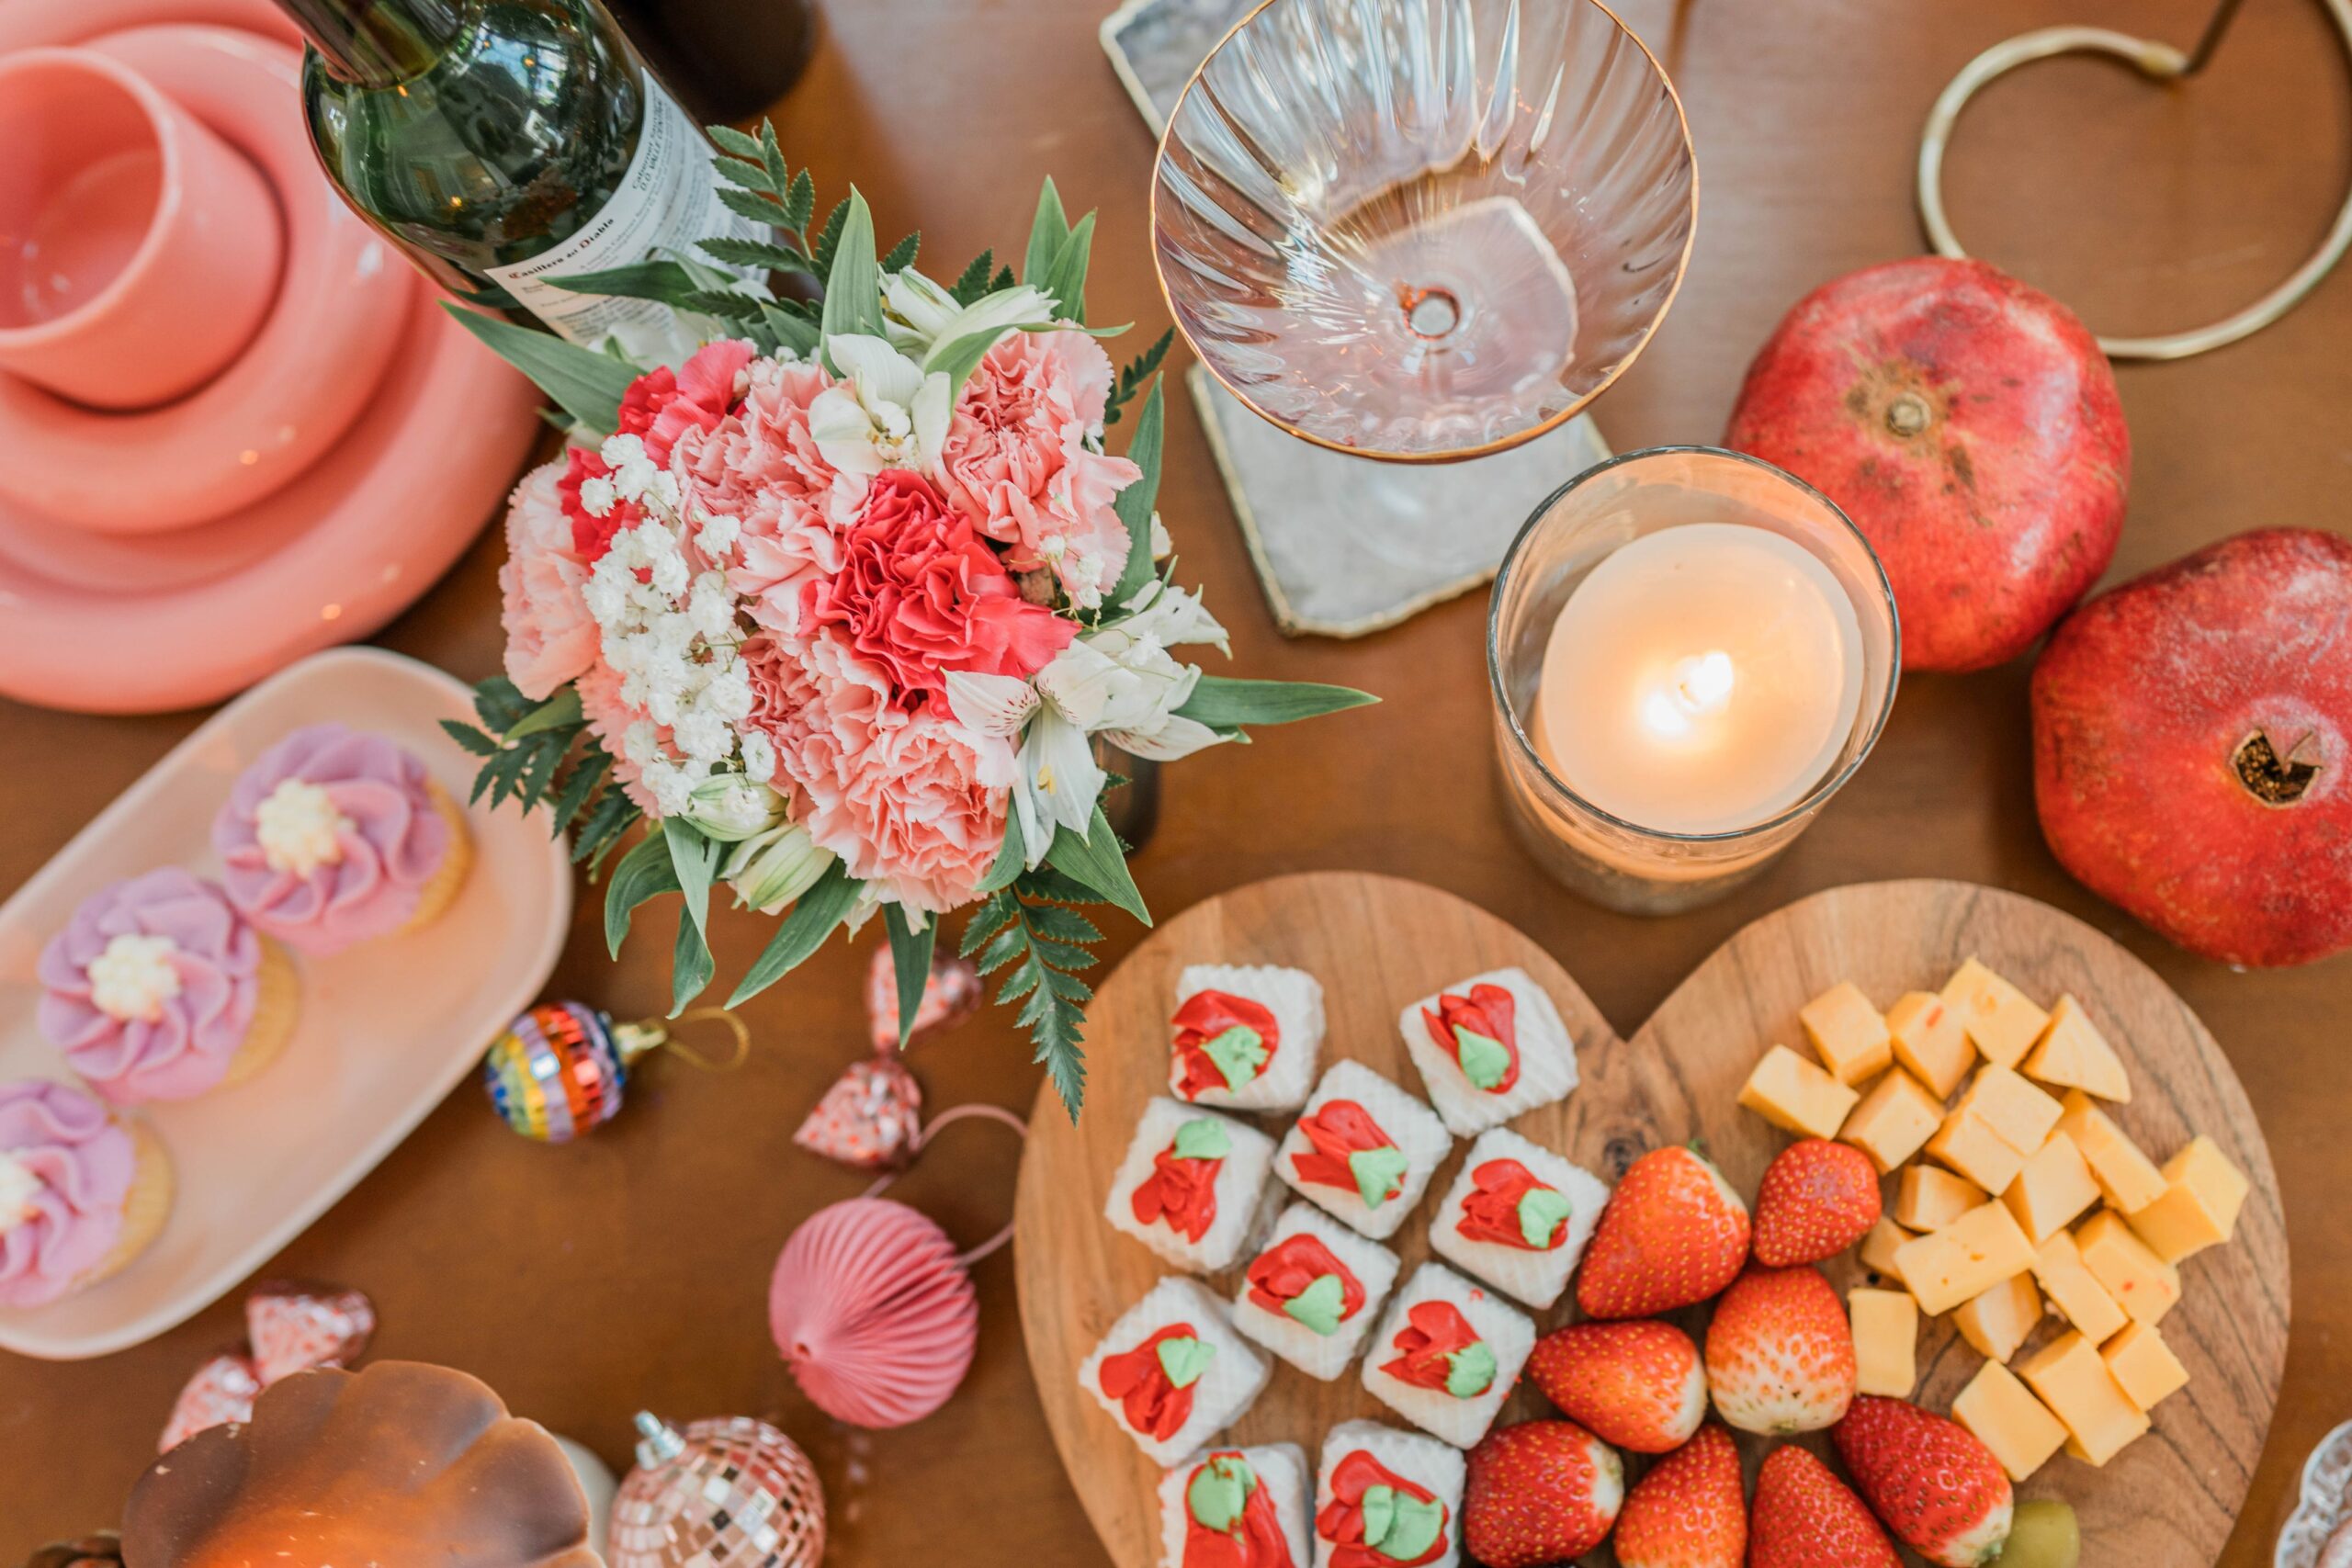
[767,1199,981,1427]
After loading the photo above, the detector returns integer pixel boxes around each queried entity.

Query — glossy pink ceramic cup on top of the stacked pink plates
[0,50,285,409]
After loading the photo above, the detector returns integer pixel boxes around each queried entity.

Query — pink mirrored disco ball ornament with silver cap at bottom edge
[605,1411,826,1568]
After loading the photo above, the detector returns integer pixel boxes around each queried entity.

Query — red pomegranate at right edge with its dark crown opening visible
[2032,529,2352,964]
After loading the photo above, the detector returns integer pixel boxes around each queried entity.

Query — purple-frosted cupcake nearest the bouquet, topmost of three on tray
[211,724,473,954]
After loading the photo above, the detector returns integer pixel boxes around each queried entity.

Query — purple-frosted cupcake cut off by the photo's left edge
[0,1079,172,1307]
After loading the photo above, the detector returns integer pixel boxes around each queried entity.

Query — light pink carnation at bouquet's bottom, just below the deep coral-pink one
[743,632,1016,915]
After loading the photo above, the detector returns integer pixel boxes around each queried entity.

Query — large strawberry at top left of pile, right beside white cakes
[1576,1147,1747,1316]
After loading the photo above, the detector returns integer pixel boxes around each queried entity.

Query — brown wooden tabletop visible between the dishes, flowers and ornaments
[0,0,2352,1568]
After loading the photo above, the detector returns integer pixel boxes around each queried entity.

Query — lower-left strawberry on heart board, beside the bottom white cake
[1463,1420,1625,1568]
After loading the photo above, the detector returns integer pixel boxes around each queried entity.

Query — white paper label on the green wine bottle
[489,73,767,365]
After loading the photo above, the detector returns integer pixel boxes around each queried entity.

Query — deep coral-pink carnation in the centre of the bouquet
[799,468,1077,707]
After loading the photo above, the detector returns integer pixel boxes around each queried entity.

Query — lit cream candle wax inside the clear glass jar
[1532,522,1863,835]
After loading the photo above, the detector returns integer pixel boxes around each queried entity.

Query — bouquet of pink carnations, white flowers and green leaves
[449,127,1371,1117]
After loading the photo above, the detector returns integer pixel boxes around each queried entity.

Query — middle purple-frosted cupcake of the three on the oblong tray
[40,870,301,1105]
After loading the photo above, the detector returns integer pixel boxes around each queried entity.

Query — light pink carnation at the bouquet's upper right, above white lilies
[941,332,1143,606]
